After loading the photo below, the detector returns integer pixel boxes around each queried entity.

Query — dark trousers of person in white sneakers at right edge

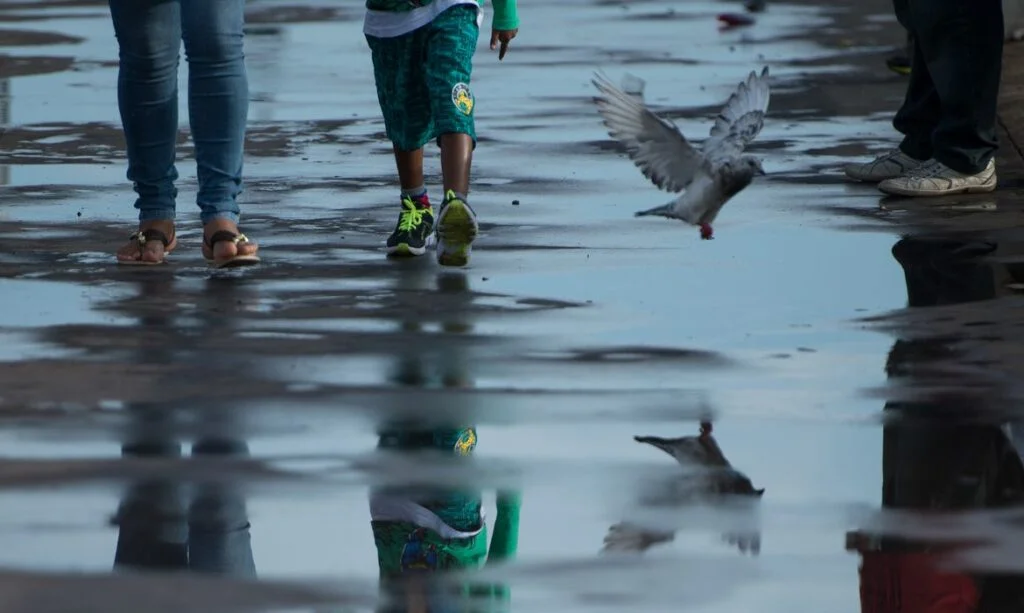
[893,0,1002,174]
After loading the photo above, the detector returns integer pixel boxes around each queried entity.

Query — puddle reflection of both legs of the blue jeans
[114,440,256,577]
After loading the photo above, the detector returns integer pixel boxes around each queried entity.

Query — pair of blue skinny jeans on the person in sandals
[110,0,249,224]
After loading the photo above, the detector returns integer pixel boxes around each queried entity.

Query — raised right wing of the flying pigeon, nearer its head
[701,67,771,165]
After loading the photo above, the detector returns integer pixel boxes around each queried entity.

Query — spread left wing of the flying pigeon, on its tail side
[593,75,705,192]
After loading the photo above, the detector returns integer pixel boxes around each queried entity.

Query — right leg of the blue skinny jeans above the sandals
[180,0,249,224]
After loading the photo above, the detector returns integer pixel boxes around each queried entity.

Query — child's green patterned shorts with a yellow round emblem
[367,4,480,151]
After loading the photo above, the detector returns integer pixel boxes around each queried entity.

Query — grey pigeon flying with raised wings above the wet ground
[593,67,770,238]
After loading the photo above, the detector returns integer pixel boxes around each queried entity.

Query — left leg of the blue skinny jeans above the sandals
[110,0,181,221]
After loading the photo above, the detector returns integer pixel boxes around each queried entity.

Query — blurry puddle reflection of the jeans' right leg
[188,439,256,577]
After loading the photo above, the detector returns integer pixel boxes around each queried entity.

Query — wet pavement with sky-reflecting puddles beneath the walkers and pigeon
[0,0,1024,613]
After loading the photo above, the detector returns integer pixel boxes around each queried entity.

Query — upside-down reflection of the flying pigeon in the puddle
[603,422,765,555]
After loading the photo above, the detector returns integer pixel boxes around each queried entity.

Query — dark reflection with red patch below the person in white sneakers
[847,236,1024,612]
